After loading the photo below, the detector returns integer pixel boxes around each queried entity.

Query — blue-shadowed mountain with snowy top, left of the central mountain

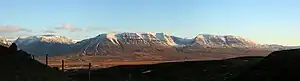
[14,35,73,55]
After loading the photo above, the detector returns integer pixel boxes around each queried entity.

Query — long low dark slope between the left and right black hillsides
[70,57,263,81]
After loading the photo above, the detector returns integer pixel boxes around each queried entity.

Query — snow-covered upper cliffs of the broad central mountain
[86,32,176,46]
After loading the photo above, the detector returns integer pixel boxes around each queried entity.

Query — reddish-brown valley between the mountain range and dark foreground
[37,49,271,69]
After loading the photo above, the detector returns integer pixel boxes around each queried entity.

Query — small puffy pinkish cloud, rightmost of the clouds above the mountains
[55,24,82,32]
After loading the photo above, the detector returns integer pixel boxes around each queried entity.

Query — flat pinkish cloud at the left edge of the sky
[0,26,32,32]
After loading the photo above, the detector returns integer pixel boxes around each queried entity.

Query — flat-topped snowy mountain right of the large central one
[191,34,257,48]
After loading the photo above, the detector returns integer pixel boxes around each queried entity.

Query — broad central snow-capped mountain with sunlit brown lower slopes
[73,32,176,55]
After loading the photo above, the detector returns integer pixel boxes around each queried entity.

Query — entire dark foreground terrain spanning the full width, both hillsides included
[0,44,300,81]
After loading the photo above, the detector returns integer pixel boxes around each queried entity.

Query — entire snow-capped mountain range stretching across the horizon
[0,32,286,56]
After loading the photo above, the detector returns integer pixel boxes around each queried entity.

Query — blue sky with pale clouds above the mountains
[0,0,300,45]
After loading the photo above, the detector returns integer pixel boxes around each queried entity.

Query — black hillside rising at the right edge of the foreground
[235,49,300,81]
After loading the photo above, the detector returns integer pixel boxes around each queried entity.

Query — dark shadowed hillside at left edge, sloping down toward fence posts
[0,43,67,81]
